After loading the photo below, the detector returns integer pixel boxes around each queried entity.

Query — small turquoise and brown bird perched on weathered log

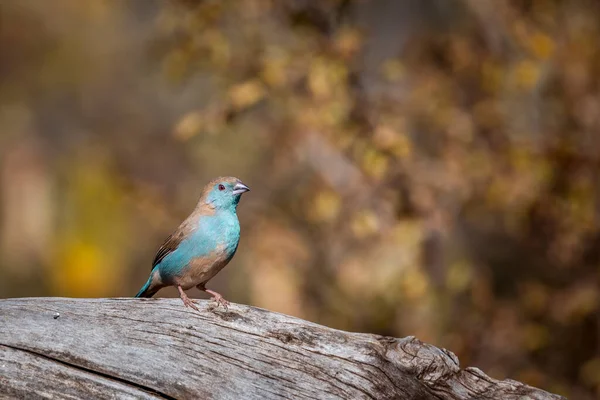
[135,177,250,311]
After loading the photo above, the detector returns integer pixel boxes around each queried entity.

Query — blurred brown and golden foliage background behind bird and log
[0,0,600,399]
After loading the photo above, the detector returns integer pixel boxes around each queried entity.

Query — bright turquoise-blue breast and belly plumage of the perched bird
[157,211,240,276]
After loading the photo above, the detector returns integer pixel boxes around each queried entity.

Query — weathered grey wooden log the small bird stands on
[0,298,562,400]
